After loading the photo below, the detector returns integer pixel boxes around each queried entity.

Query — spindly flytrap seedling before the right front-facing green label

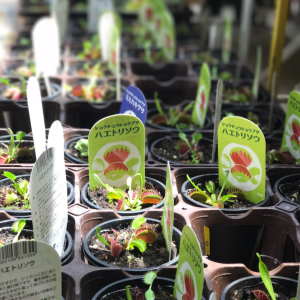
[186,170,244,208]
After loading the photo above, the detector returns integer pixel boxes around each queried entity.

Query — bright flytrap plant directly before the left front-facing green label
[94,173,162,211]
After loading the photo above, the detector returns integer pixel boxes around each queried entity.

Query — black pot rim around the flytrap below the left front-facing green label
[81,176,166,217]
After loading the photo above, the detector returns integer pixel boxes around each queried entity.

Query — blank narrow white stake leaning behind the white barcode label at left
[27,77,46,159]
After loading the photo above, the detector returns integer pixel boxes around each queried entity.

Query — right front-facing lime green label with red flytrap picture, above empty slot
[218,117,266,204]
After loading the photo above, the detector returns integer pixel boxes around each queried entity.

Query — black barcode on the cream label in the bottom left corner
[0,241,37,260]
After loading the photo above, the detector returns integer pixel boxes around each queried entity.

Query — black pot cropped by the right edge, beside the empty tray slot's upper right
[274,174,300,205]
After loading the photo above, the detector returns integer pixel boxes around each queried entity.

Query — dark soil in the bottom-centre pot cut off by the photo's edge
[101,286,175,300]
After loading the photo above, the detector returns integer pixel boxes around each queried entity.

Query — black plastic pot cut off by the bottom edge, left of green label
[92,277,205,300]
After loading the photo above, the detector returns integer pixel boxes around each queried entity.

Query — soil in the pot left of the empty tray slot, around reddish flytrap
[89,224,177,269]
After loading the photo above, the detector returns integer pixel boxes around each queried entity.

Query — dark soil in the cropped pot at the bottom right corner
[231,282,296,300]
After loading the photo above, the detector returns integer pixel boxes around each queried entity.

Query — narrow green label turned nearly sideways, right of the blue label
[192,63,210,128]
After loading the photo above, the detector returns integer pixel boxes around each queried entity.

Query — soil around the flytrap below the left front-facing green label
[87,181,162,210]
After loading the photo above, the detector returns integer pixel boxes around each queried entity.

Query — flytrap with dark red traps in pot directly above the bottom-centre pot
[96,217,157,258]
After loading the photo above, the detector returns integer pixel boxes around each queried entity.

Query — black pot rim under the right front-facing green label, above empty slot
[181,174,270,215]
